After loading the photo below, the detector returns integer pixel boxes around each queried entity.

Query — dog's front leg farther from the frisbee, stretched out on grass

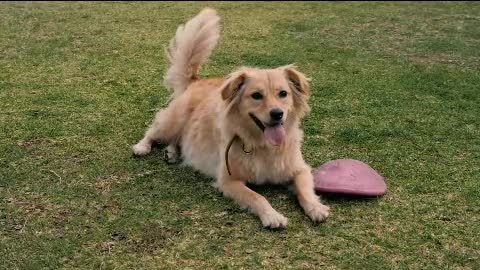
[218,172,288,228]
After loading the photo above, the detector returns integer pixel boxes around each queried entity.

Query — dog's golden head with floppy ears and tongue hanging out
[221,65,310,145]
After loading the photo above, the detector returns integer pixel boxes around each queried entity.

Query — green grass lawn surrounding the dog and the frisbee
[0,2,480,269]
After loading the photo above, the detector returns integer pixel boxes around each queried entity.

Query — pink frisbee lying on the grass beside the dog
[312,159,387,196]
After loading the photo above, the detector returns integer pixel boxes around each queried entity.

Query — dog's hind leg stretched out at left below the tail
[132,98,188,155]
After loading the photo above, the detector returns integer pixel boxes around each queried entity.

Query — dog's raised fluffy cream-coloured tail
[165,8,220,97]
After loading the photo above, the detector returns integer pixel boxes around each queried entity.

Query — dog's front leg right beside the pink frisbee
[294,169,330,222]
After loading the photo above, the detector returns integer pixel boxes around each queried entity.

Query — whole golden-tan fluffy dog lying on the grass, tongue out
[133,9,329,228]
